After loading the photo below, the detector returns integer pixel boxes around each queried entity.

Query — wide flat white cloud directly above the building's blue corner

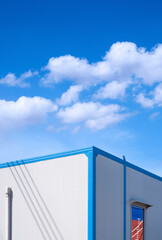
[57,102,128,130]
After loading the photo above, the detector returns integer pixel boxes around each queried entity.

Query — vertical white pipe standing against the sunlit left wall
[5,187,13,240]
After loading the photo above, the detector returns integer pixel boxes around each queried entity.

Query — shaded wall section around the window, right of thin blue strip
[126,167,162,240]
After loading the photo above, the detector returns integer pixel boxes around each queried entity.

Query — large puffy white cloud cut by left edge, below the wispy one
[0,96,57,130]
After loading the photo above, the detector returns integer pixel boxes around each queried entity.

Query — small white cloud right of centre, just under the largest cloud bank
[94,81,129,99]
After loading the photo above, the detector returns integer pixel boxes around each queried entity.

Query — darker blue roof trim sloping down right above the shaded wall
[94,147,162,182]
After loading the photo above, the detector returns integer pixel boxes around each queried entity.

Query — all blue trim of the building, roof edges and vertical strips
[0,146,162,240]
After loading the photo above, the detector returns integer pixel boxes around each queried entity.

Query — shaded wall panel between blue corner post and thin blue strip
[96,155,123,240]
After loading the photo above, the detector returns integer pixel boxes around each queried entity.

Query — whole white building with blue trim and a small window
[0,147,162,240]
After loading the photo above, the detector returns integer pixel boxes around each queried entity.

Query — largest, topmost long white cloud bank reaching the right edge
[42,42,162,85]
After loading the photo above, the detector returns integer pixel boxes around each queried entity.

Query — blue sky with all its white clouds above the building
[0,0,162,175]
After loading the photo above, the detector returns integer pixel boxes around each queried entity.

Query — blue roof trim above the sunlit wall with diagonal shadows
[0,147,93,169]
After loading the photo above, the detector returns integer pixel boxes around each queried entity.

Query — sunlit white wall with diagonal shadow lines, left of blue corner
[0,154,88,240]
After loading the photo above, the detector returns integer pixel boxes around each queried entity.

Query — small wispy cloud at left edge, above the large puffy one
[0,70,38,88]
